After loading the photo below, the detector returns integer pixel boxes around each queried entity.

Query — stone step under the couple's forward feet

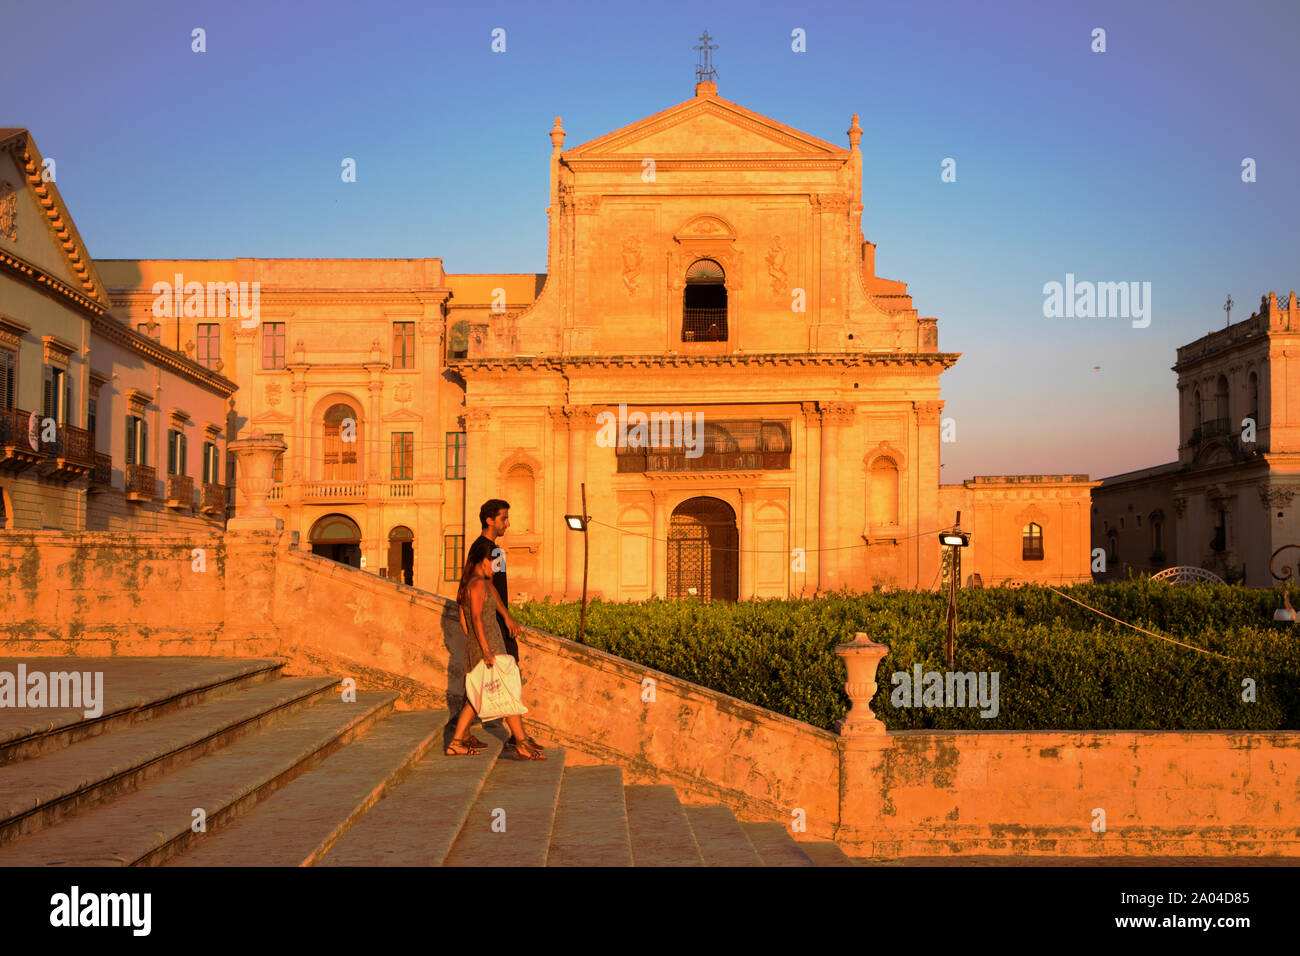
[443,748,564,866]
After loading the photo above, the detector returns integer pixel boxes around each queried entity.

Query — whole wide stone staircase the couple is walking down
[0,657,854,866]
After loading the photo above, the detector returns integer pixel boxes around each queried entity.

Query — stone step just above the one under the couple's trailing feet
[172,710,447,866]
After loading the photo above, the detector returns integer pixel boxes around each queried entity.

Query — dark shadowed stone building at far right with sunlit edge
[1092,293,1300,587]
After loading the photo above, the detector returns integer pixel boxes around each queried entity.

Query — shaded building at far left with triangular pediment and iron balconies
[0,129,235,531]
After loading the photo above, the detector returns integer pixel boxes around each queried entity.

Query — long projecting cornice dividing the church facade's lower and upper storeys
[446,352,961,372]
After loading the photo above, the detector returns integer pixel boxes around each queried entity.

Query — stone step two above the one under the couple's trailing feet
[0,692,397,866]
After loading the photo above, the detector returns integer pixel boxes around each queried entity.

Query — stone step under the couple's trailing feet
[316,714,506,866]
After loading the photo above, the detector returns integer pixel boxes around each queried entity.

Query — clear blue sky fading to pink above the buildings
[0,0,1300,483]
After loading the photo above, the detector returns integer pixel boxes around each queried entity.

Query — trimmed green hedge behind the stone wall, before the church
[512,578,1300,730]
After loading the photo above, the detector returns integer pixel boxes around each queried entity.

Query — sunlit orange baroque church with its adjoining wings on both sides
[0,81,1097,601]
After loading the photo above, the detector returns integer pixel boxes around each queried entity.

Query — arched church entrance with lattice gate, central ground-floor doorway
[668,498,740,601]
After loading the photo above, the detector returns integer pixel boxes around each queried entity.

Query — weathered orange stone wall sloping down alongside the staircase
[0,532,1300,857]
